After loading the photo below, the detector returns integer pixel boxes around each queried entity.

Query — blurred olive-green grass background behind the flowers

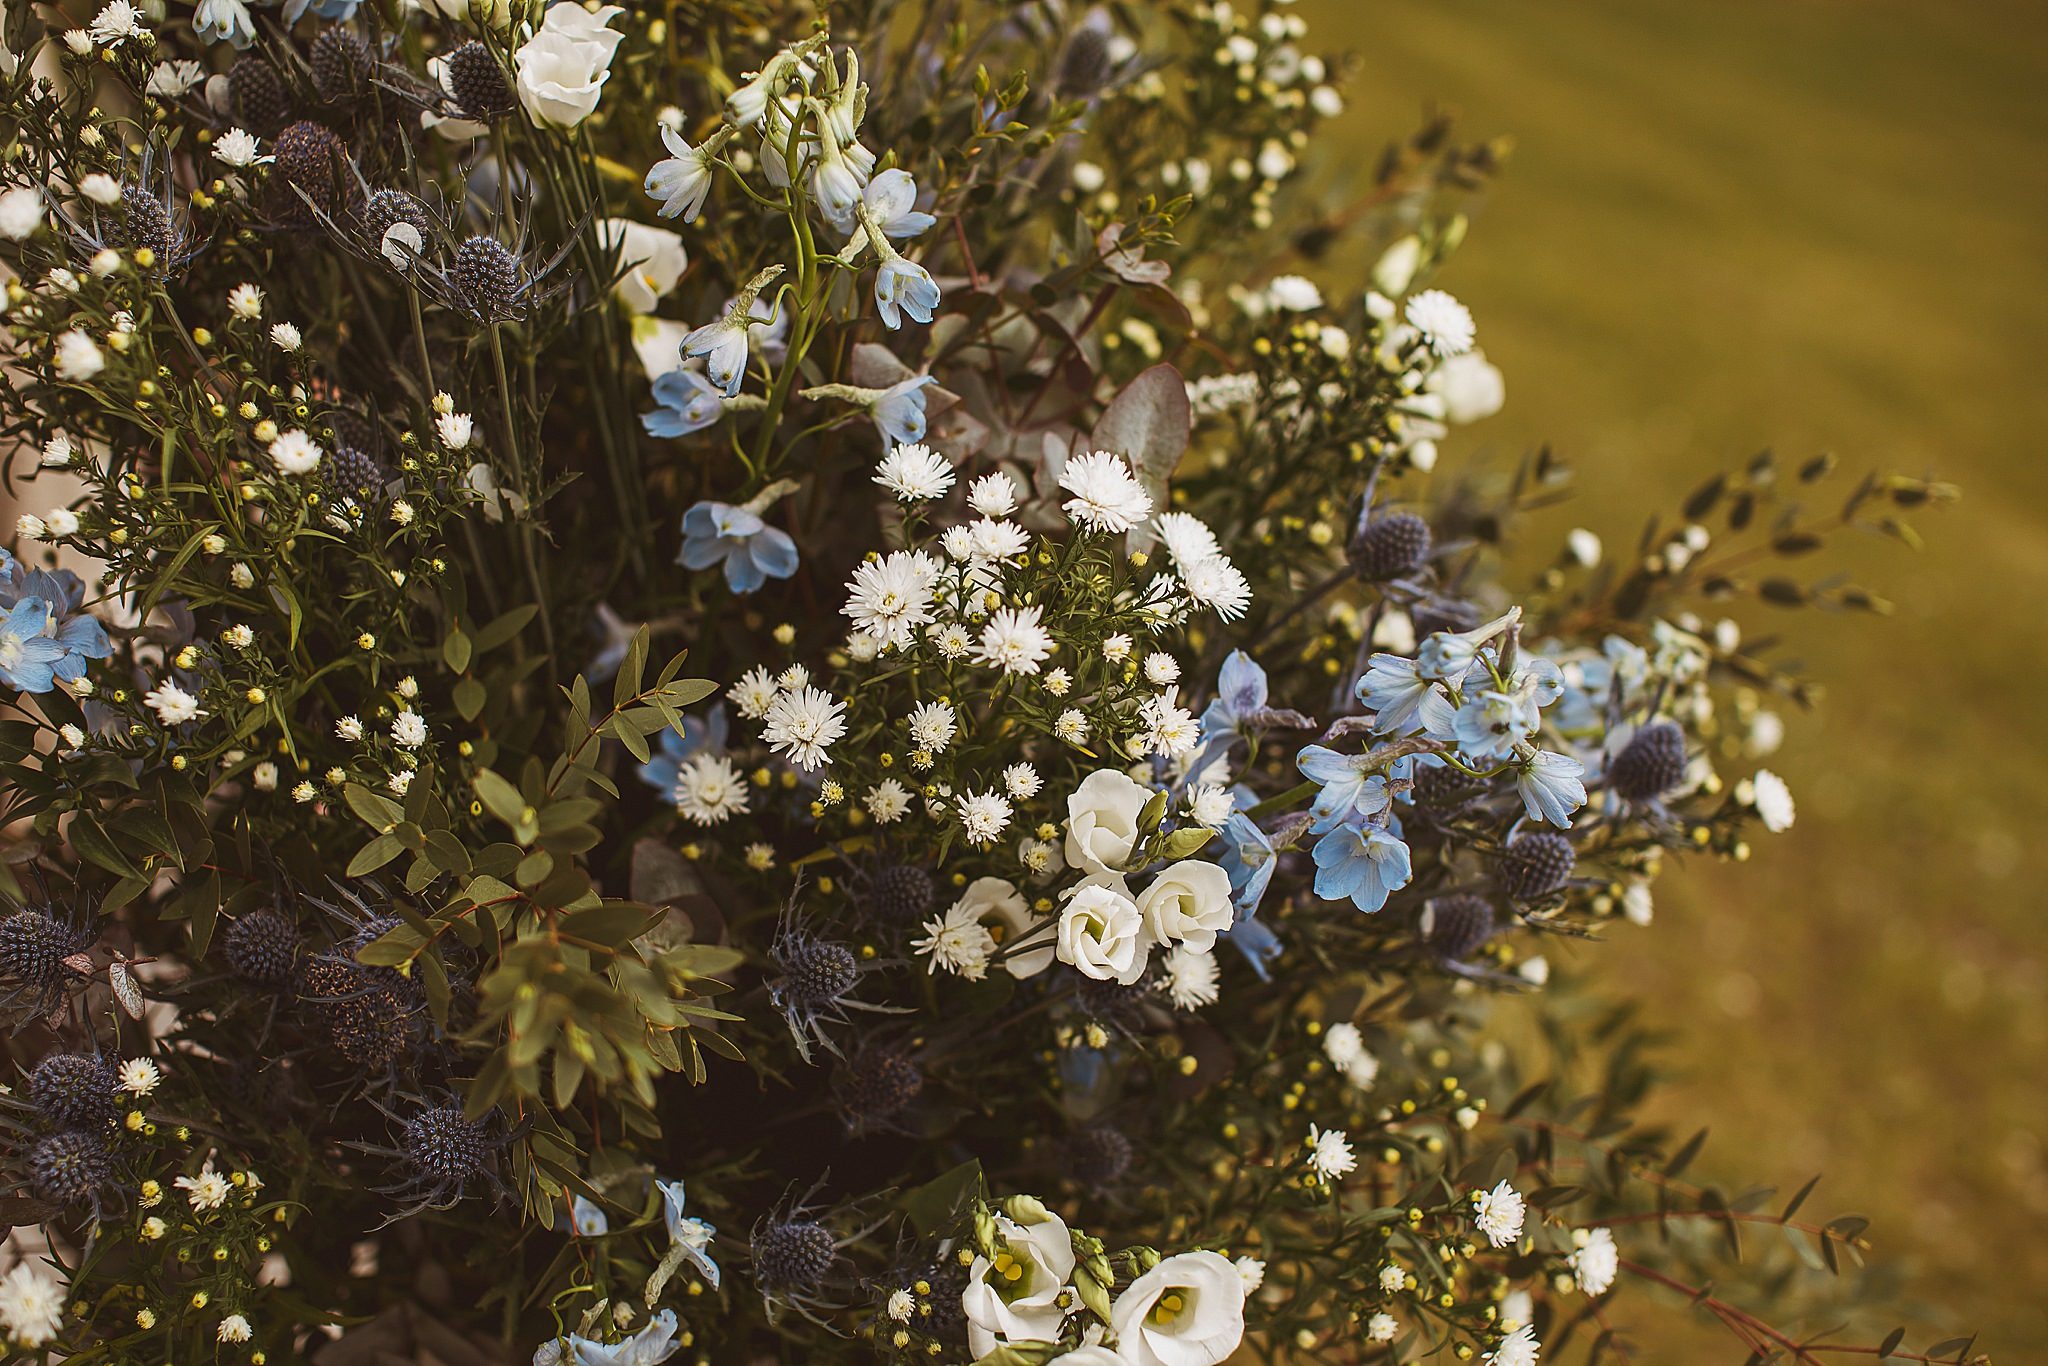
[1303,0,2048,1362]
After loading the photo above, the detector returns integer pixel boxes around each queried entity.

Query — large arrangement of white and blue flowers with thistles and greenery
[0,0,1972,1366]
